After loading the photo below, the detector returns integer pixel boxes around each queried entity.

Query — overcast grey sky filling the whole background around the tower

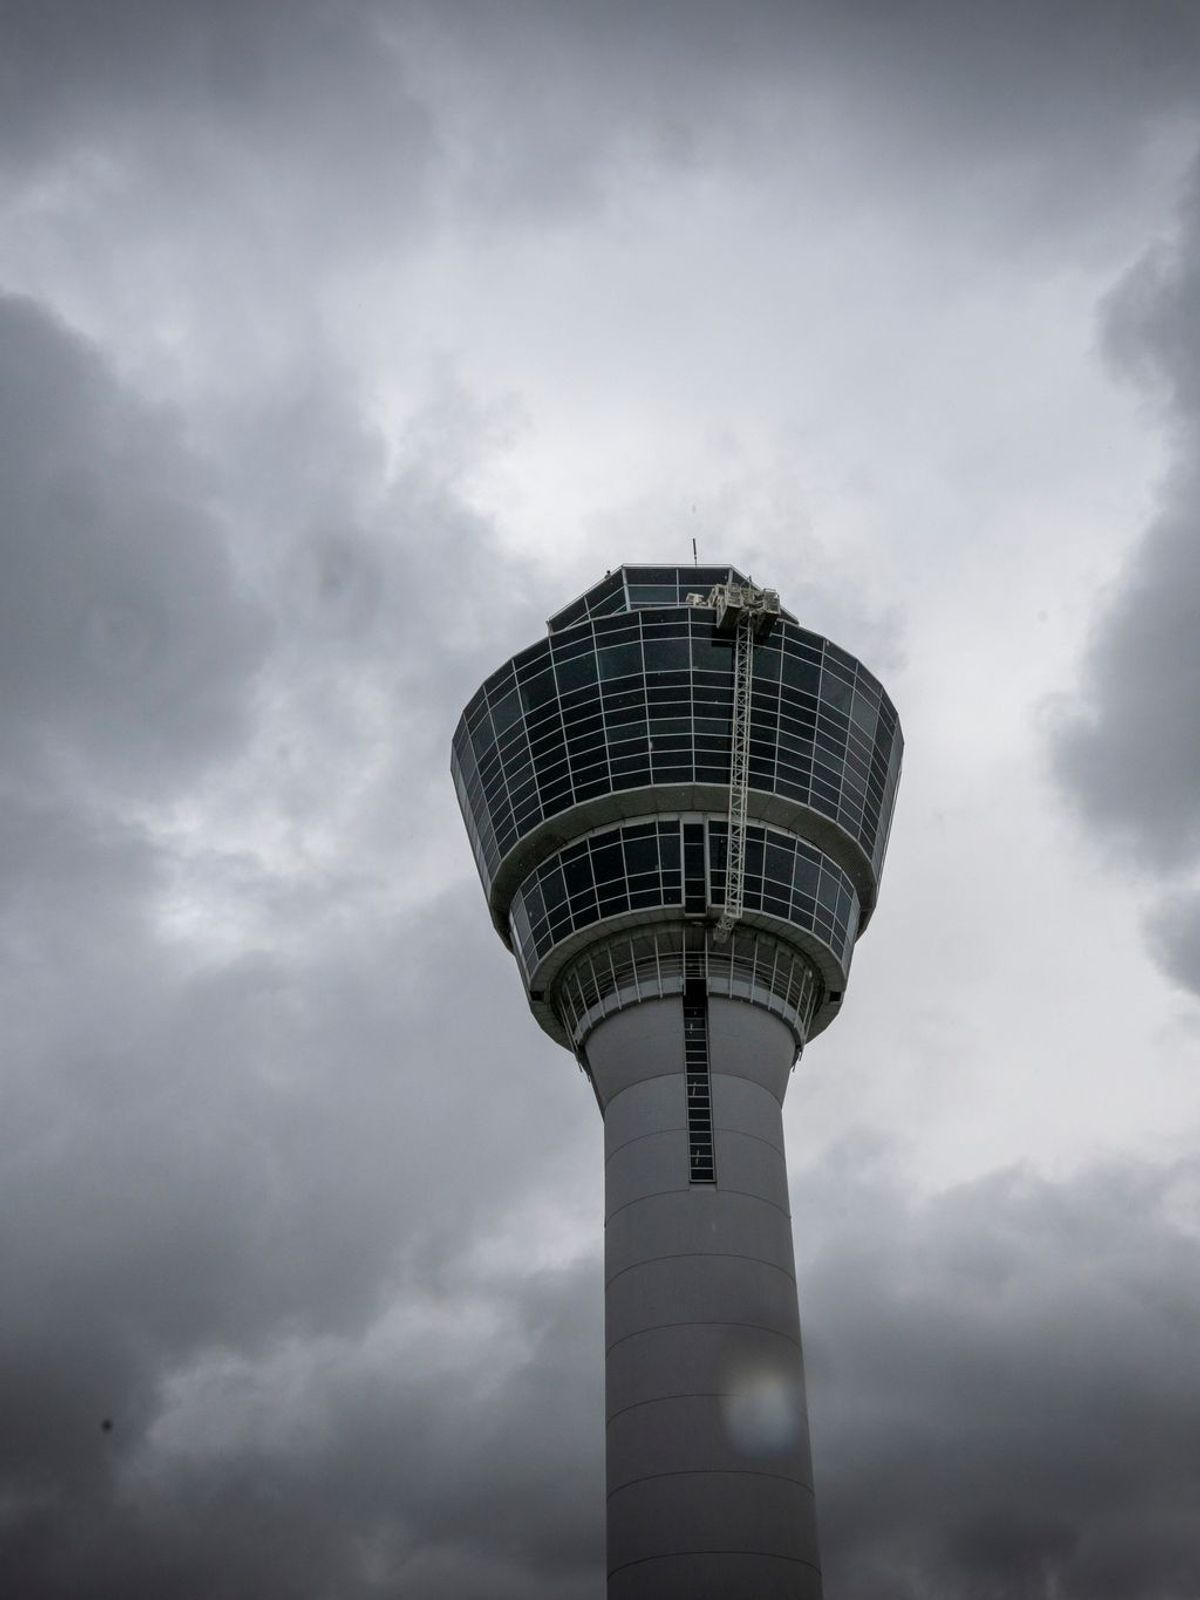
[0,0,1200,1600]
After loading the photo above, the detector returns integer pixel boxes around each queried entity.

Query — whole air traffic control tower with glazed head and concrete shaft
[451,566,902,1600]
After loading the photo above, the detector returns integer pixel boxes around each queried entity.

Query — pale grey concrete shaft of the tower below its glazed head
[587,998,821,1600]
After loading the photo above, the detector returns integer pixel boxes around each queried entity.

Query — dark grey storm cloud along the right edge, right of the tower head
[1054,162,1200,989]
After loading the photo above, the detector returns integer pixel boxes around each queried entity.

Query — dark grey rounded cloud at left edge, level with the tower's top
[0,298,269,794]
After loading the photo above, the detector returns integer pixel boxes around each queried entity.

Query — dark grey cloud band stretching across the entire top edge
[0,0,1200,252]
